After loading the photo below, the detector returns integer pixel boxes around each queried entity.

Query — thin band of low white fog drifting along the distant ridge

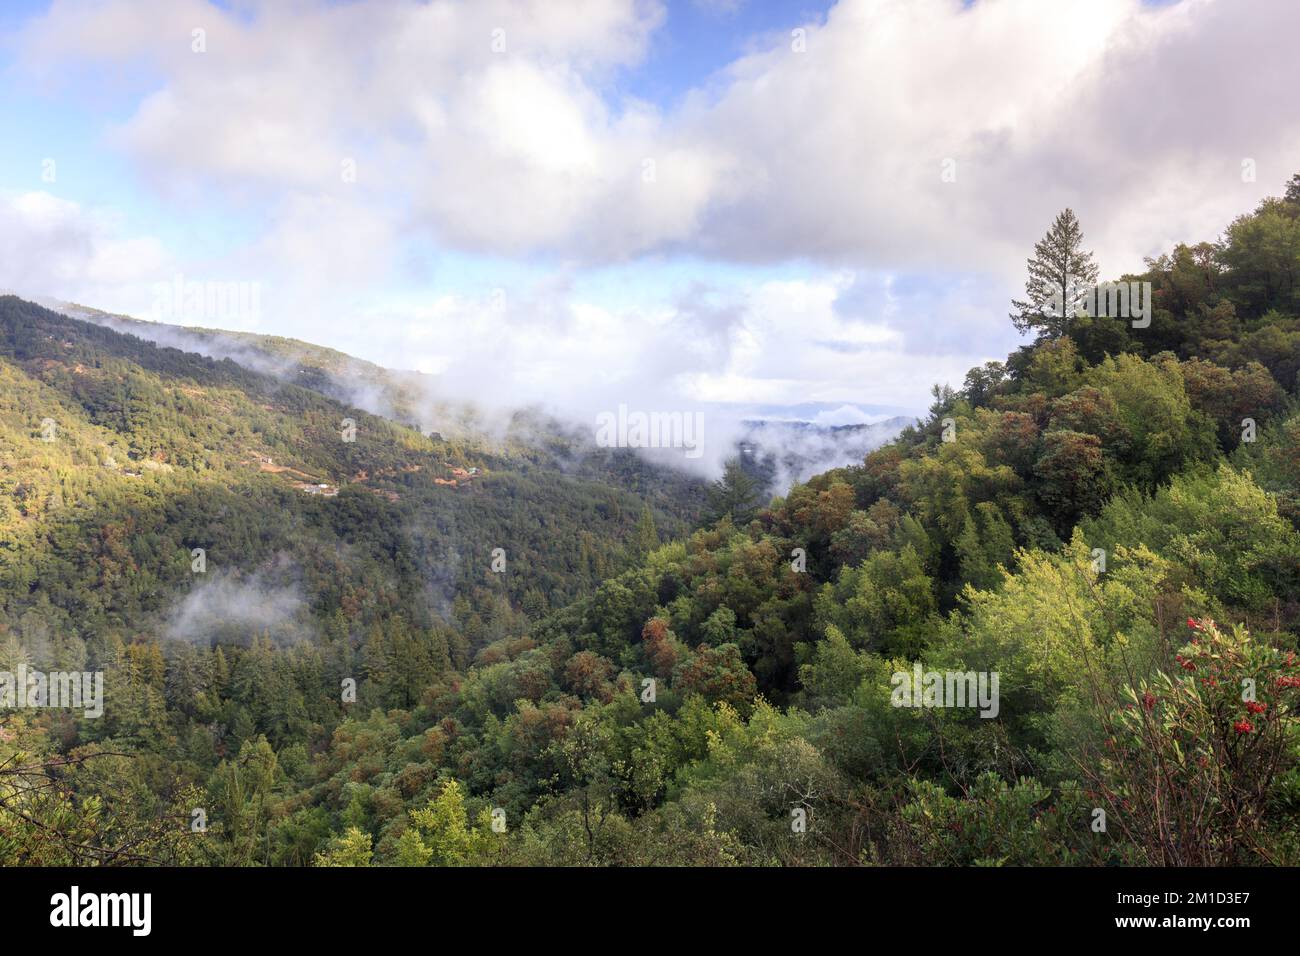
[43,300,917,494]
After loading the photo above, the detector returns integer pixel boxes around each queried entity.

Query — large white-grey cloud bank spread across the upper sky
[22,0,1300,274]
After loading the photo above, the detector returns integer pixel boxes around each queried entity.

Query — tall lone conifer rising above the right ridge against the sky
[1011,209,1097,338]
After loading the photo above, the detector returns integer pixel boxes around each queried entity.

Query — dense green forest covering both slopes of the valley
[0,177,1300,865]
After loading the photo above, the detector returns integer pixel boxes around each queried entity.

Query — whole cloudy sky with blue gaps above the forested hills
[0,0,1300,423]
